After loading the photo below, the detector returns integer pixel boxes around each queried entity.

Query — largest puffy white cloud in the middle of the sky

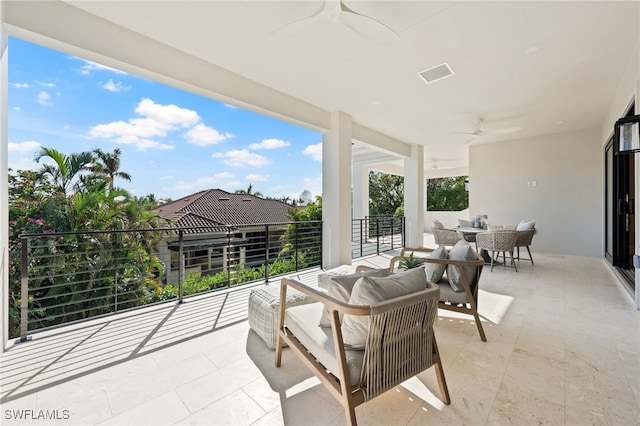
[88,99,200,150]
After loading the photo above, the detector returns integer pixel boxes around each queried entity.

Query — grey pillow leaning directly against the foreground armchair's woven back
[342,268,427,349]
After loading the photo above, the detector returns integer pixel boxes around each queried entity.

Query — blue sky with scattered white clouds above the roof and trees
[8,38,322,200]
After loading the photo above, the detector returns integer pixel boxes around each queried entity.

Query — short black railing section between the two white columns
[351,216,405,259]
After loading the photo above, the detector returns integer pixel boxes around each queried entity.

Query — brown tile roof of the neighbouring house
[155,189,293,230]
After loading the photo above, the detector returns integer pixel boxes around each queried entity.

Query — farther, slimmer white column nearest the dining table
[404,145,426,247]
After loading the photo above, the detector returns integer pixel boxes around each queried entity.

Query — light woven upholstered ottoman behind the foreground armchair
[248,283,320,349]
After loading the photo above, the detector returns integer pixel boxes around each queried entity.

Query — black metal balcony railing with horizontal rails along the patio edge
[9,218,404,341]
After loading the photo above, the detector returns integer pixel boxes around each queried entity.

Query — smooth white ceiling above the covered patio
[6,0,640,173]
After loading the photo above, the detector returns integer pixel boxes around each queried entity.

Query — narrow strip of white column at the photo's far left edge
[0,10,9,352]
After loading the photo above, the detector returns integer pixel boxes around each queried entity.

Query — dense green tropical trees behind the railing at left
[8,147,168,335]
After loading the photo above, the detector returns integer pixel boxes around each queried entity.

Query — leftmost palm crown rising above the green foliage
[34,147,93,195]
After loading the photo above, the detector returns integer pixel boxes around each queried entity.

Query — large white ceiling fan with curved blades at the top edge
[267,0,400,42]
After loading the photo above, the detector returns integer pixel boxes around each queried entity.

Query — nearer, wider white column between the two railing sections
[322,111,352,268]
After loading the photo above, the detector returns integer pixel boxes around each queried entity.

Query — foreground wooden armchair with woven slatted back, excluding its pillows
[275,278,451,425]
